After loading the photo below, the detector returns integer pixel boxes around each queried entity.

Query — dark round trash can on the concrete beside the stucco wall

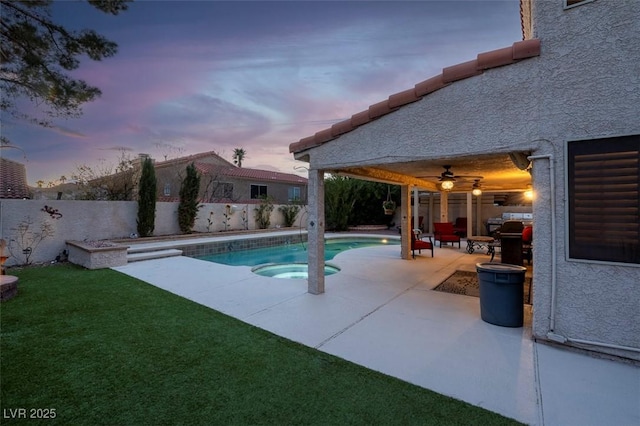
[476,263,527,327]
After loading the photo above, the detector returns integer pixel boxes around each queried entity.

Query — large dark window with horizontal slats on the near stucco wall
[567,135,640,264]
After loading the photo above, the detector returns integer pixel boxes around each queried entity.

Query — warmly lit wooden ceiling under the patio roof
[327,153,531,192]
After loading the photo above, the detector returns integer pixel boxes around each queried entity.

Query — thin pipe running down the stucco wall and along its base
[527,154,640,353]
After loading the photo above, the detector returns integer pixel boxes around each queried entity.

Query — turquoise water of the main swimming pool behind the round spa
[198,238,400,266]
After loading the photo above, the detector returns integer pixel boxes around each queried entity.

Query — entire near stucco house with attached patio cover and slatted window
[290,0,640,360]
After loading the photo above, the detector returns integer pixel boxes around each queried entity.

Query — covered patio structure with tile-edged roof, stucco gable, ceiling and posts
[290,39,544,294]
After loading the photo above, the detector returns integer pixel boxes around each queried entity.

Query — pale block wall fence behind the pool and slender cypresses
[0,199,306,266]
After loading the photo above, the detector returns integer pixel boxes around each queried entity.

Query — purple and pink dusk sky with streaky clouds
[2,0,522,186]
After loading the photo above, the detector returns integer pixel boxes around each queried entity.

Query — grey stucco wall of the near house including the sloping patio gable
[298,0,640,359]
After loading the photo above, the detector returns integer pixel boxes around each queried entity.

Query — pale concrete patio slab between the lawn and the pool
[114,235,640,426]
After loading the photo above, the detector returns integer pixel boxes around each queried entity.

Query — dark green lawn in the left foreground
[0,265,516,425]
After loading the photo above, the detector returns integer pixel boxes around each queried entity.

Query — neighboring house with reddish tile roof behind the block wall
[155,151,307,204]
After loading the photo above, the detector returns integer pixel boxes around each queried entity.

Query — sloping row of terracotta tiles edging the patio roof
[289,39,540,153]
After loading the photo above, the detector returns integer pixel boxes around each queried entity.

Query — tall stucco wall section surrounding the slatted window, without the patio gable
[532,0,640,359]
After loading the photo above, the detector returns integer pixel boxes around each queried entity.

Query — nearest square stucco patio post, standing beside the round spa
[307,169,324,294]
